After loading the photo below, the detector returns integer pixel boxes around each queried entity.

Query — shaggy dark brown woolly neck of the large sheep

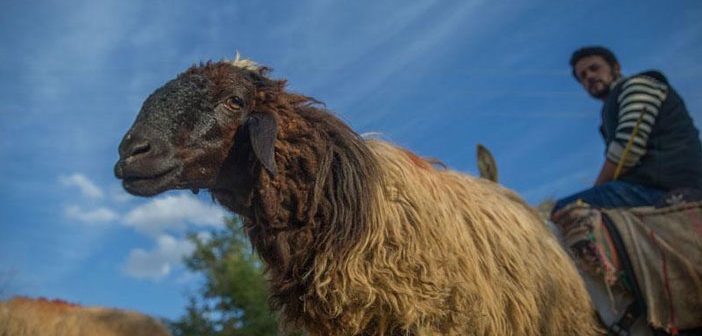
[238,103,377,322]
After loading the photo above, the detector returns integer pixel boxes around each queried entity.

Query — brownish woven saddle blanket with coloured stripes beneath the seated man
[553,202,702,334]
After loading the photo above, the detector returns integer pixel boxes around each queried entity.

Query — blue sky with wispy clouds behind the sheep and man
[0,0,702,318]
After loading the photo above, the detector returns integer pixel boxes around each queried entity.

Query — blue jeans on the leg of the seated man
[551,181,665,213]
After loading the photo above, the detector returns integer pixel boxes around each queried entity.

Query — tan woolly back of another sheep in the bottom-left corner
[0,297,170,336]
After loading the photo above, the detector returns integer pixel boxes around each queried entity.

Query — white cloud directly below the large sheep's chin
[124,193,226,235]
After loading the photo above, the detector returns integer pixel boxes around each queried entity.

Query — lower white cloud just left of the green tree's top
[124,235,195,281]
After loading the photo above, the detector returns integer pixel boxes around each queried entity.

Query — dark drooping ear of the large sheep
[246,112,278,176]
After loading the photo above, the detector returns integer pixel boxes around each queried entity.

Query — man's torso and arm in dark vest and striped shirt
[600,70,702,190]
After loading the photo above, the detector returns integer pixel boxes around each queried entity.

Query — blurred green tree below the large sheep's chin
[170,218,278,336]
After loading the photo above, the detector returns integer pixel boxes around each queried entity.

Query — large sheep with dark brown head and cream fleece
[115,56,600,335]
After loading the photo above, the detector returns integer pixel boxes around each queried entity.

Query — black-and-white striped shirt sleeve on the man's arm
[607,75,668,168]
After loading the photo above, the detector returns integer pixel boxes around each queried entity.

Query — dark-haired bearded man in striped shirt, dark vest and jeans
[554,46,702,213]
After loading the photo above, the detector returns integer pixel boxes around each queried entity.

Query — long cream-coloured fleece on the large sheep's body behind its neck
[359,140,595,335]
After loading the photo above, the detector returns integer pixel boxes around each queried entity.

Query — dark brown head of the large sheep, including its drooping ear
[115,56,280,196]
